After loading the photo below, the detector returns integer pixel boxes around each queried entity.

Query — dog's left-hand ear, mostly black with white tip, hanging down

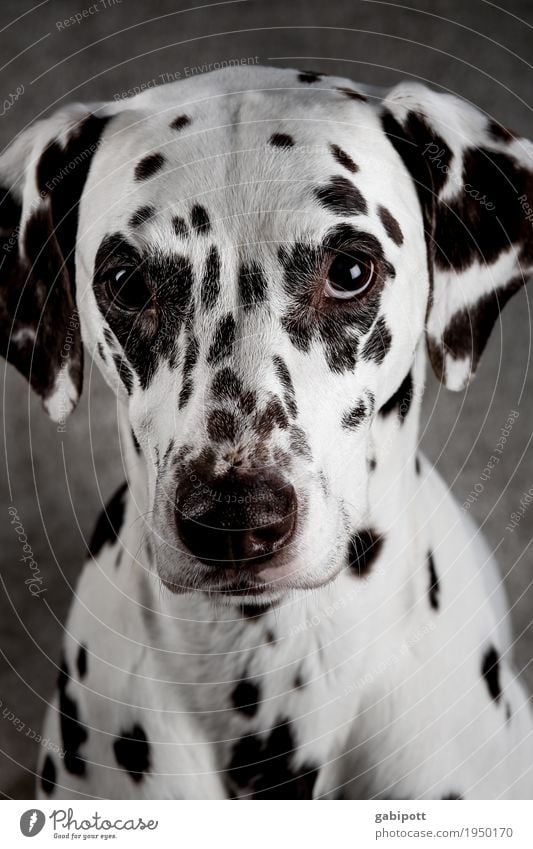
[0,105,107,421]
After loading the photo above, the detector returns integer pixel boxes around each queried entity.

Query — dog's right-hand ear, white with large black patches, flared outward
[382,83,533,390]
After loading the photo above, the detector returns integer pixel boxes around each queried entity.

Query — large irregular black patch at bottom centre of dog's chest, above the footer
[228,720,319,799]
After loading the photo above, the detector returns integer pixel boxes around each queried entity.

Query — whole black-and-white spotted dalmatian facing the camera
[0,68,533,799]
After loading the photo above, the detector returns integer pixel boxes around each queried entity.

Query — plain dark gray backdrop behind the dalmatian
[0,0,533,797]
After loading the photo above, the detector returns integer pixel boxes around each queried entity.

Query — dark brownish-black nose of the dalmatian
[175,473,297,568]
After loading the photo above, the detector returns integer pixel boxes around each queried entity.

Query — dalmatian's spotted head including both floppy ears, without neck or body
[0,64,531,598]
